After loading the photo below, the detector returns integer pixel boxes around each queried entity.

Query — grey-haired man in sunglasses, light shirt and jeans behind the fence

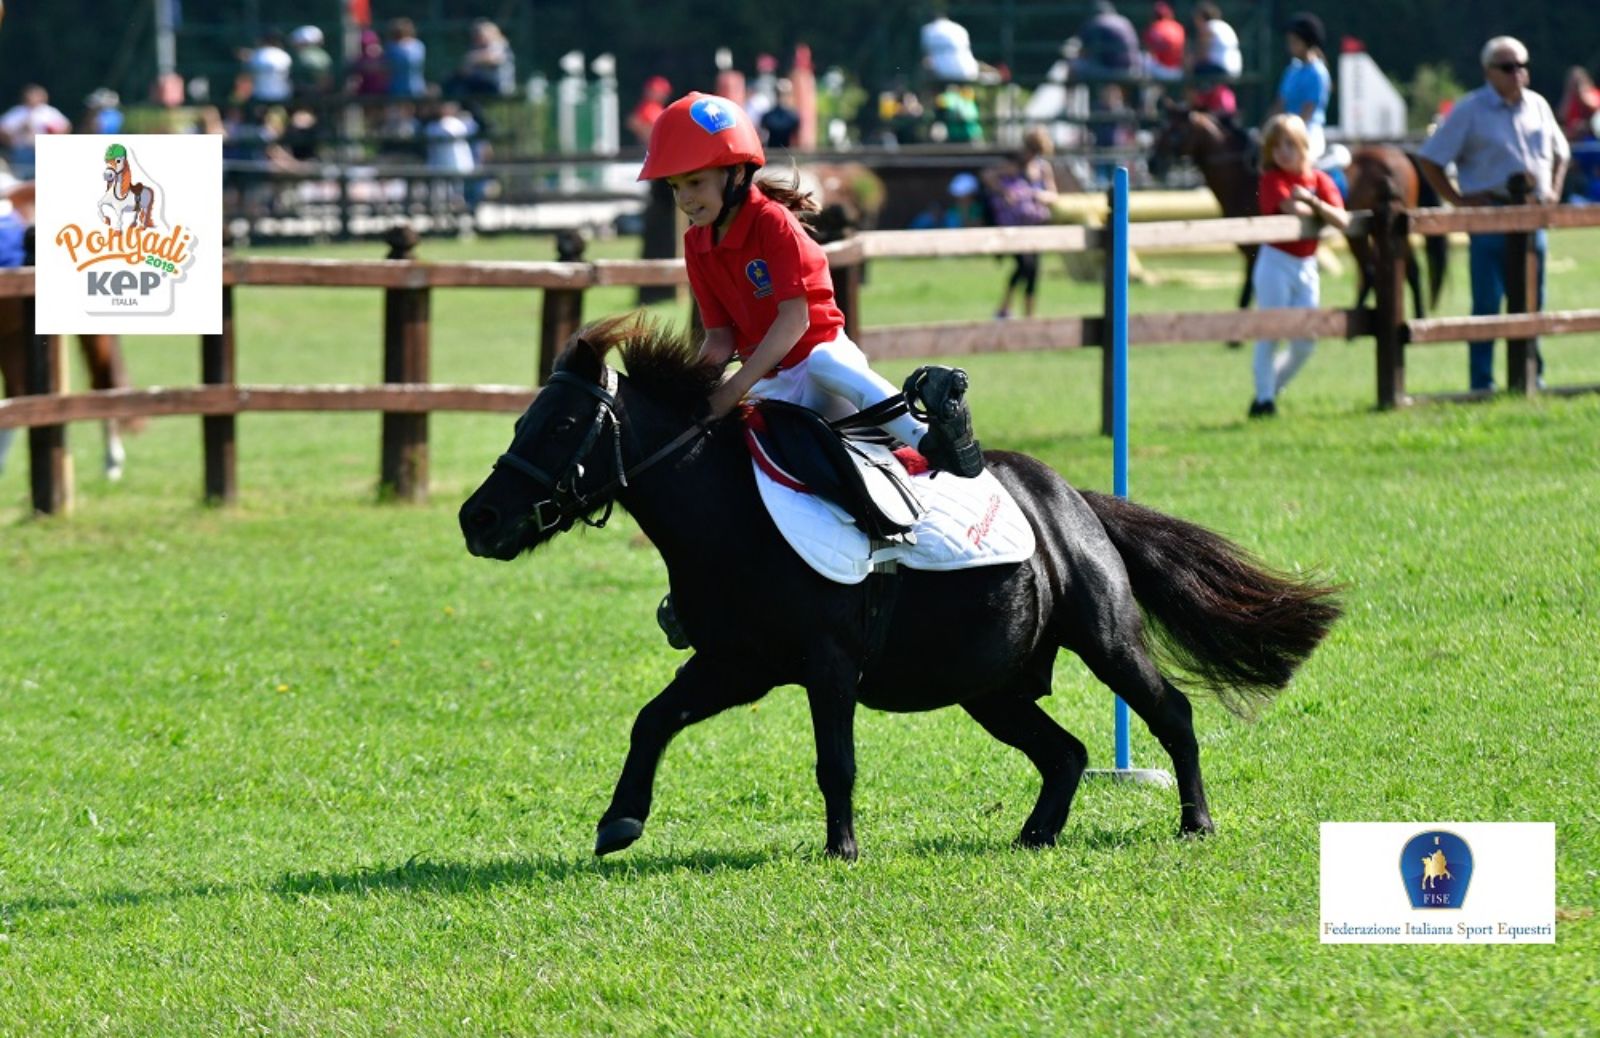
[1418,37,1571,390]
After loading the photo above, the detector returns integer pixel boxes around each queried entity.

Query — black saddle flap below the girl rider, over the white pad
[744,400,923,539]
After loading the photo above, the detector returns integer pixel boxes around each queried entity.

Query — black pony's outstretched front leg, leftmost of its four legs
[595,653,773,854]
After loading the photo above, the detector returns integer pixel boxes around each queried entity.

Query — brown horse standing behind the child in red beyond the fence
[1149,106,1448,317]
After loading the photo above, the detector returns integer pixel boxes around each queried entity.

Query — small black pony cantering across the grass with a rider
[461,317,1339,859]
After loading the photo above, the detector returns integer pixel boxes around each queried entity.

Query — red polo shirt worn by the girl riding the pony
[683,186,845,368]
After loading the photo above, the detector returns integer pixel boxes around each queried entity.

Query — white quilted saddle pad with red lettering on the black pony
[750,462,1034,584]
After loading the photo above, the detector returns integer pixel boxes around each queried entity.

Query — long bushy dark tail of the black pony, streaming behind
[1083,491,1341,715]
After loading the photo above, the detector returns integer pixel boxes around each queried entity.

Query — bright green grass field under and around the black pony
[0,232,1600,1036]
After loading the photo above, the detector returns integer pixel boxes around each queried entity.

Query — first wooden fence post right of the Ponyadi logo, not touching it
[378,227,429,502]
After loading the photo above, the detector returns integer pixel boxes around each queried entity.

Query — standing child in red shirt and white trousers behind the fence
[1250,114,1350,417]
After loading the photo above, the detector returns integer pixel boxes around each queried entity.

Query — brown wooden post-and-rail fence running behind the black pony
[0,198,1600,513]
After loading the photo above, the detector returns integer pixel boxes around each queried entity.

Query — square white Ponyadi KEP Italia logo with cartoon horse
[35,134,222,334]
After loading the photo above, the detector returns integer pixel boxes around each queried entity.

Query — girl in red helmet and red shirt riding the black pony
[638,93,984,477]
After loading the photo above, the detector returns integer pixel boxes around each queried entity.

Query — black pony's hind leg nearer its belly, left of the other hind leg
[962,649,1090,848]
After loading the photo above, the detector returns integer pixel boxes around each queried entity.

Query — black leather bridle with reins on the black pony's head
[494,366,707,534]
